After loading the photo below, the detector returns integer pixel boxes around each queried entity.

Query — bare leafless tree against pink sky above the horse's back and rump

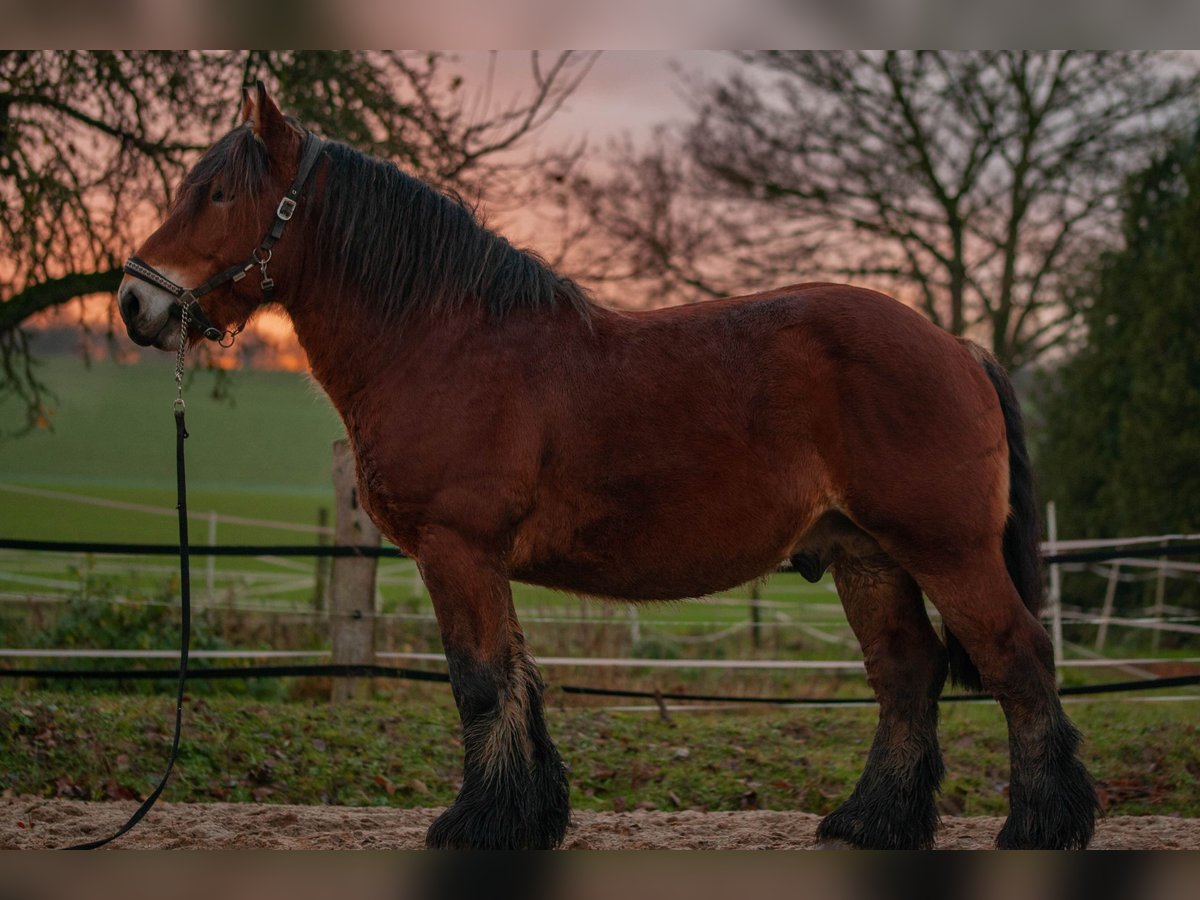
[566,52,1200,366]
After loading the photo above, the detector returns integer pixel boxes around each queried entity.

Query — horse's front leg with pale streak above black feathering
[420,529,569,850]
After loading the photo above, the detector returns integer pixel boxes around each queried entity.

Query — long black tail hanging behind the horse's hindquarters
[946,341,1043,691]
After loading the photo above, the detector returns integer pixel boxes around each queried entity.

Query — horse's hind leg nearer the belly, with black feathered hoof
[817,541,947,850]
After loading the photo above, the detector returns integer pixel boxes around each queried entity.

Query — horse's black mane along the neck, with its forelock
[176,126,592,322]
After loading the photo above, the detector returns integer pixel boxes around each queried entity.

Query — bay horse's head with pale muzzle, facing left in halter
[118,82,319,350]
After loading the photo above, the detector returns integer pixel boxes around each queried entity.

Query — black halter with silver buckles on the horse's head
[124,131,325,347]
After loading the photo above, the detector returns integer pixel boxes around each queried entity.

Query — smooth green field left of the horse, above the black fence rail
[0,356,344,541]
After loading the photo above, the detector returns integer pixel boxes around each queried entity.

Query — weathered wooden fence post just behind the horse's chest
[329,440,379,703]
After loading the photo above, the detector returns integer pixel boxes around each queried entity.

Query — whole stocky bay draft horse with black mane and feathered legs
[119,84,1097,848]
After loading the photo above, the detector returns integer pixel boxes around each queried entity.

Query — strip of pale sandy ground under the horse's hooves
[0,797,1200,850]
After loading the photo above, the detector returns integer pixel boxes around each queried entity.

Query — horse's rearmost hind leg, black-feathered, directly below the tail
[917,547,1097,850]
